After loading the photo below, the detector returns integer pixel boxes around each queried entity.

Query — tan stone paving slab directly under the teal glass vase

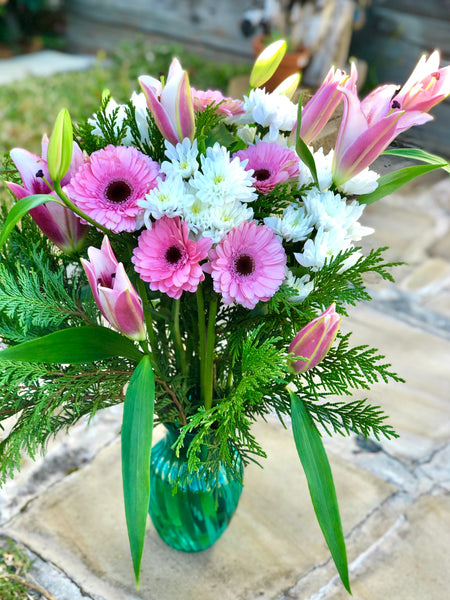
[4,423,396,600]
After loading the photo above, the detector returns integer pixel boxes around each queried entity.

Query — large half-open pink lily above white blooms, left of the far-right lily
[332,87,432,186]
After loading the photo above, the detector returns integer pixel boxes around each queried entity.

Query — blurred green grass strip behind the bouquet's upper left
[0,40,249,154]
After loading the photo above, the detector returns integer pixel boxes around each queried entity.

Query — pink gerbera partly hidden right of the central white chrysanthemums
[233,142,299,194]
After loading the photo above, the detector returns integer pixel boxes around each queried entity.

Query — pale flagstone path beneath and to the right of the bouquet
[0,62,450,600]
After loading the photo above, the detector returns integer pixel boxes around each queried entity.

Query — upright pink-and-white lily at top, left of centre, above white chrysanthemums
[139,58,195,145]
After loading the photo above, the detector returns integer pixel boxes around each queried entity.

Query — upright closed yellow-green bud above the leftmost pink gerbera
[47,108,73,182]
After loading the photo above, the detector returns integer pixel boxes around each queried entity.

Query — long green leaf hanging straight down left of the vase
[122,355,155,586]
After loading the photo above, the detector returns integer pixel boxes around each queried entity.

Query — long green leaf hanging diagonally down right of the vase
[290,392,351,594]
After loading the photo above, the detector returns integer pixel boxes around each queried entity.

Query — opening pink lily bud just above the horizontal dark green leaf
[81,236,146,341]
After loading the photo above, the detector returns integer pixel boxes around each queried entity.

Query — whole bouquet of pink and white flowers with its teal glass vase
[0,44,450,590]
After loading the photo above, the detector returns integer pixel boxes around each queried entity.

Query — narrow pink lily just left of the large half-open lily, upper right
[292,63,358,144]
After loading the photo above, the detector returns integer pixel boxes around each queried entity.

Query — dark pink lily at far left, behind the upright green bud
[5,136,88,254]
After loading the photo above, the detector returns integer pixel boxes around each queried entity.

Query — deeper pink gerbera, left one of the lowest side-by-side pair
[131,216,212,298]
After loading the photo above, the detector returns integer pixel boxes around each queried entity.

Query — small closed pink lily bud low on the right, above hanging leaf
[289,303,341,373]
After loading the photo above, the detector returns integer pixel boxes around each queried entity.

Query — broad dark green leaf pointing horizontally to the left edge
[0,326,142,364]
